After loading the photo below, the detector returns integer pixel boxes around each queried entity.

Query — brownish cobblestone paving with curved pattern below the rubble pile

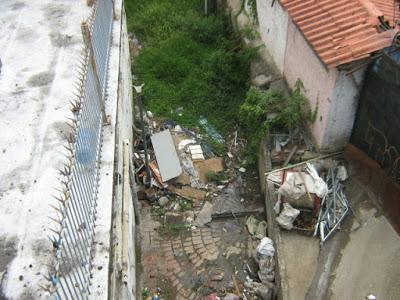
[141,207,257,300]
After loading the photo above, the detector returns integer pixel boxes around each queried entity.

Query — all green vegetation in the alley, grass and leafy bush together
[125,0,318,165]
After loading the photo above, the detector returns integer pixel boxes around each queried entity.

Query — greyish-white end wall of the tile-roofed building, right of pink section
[322,68,366,149]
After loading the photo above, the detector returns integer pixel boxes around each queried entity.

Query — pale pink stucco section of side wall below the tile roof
[284,20,337,148]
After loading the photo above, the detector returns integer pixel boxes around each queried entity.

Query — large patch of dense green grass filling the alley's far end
[126,0,256,134]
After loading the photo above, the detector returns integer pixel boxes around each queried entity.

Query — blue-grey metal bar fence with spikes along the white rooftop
[43,0,113,299]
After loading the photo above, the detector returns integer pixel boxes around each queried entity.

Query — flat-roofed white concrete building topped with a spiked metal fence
[0,0,135,299]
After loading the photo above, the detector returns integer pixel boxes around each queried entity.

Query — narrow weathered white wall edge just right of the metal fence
[109,1,136,300]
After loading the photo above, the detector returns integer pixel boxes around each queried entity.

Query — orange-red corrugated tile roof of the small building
[280,0,400,67]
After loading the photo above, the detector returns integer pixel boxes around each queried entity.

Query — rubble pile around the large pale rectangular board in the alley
[133,111,253,228]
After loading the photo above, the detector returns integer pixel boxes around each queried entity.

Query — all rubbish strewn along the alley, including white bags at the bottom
[134,111,275,300]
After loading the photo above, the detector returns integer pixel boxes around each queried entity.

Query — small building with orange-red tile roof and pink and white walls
[257,0,400,150]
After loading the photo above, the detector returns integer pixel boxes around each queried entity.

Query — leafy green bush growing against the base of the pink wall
[239,80,318,164]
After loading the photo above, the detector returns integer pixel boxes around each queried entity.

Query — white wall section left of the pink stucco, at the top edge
[257,0,288,74]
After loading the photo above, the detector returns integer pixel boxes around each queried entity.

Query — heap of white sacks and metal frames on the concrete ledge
[267,159,349,243]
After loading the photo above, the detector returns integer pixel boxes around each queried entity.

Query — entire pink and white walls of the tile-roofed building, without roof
[257,0,365,150]
